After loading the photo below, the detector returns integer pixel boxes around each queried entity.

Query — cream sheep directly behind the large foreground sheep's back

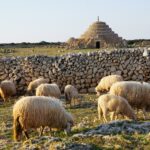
[36,83,61,99]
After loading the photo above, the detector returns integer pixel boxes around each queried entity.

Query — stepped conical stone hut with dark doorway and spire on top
[67,17,126,49]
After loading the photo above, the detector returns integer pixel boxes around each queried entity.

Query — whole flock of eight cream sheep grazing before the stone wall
[0,75,150,140]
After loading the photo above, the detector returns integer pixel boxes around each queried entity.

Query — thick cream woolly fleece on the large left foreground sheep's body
[13,96,71,129]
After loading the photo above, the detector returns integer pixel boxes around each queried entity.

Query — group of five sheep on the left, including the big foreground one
[0,78,79,140]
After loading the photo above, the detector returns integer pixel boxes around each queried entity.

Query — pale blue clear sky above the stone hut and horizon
[0,0,150,43]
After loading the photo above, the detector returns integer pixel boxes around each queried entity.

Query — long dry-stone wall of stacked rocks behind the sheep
[0,49,150,93]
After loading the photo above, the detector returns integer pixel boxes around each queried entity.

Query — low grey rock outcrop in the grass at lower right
[73,120,150,138]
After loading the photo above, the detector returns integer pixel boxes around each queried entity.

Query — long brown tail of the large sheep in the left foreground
[13,116,22,141]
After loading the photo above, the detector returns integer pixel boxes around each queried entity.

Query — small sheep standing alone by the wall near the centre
[64,85,80,105]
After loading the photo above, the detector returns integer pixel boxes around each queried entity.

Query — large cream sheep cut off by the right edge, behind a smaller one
[110,81,150,119]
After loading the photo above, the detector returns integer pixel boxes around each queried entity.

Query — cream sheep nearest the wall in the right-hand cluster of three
[95,75,123,96]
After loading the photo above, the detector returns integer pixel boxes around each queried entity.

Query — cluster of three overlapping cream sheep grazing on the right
[95,75,150,122]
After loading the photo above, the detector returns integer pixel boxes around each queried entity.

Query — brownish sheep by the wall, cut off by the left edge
[0,80,16,102]
